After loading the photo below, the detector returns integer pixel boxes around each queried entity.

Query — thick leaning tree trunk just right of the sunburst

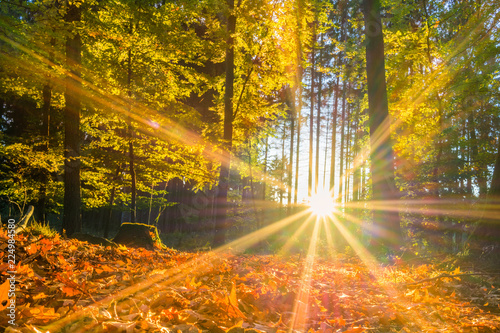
[363,0,402,248]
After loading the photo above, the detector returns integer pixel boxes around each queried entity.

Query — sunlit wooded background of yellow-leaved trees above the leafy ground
[0,0,500,251]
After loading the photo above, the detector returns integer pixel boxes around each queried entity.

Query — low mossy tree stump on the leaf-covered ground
[113,222,164,249]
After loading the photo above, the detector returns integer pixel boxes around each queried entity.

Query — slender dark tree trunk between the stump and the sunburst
[214,0,236,246]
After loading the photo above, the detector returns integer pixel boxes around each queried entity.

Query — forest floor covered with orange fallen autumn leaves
[0,229,500,333]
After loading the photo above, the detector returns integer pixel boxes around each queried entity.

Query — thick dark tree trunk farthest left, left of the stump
[62,4,82,235]
